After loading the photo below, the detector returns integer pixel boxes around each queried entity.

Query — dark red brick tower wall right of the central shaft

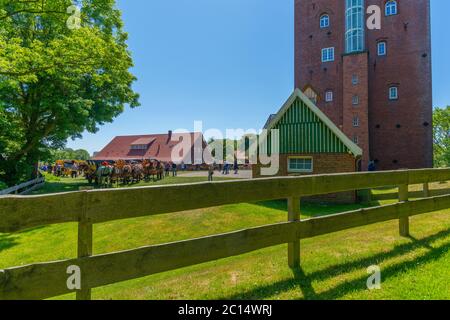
[367,0,433,170]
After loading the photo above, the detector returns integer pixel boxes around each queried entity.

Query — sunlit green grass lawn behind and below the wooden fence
[0,177,450,299]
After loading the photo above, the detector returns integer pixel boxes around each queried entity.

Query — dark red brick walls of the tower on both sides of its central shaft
[295,0,433,170]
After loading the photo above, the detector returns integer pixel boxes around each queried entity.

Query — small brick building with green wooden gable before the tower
[253,89,362,201]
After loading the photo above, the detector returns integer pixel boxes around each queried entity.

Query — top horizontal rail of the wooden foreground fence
[0,169,450,232]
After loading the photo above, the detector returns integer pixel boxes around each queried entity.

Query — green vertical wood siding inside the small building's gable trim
[268,99,349,154]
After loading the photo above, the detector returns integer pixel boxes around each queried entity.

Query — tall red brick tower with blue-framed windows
[295,0,433,170]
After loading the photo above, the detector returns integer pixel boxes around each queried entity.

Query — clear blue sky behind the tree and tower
[68,0,450,153]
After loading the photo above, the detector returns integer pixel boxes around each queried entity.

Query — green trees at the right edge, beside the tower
[433,106,450,167]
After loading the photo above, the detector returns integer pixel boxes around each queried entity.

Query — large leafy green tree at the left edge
[0,0,138,184]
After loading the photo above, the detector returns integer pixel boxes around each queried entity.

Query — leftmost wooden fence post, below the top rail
[76,192,93,300]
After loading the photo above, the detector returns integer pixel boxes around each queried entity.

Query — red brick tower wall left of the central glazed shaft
[295,0,345,129]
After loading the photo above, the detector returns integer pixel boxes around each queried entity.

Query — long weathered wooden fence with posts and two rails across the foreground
[0,169,450,300]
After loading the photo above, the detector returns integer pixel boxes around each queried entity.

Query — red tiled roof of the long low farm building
[92,131,206,165]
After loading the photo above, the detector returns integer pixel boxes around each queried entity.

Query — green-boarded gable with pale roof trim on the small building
[268,89,362,156]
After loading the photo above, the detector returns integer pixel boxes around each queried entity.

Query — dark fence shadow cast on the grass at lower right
[223,229,450,300]
